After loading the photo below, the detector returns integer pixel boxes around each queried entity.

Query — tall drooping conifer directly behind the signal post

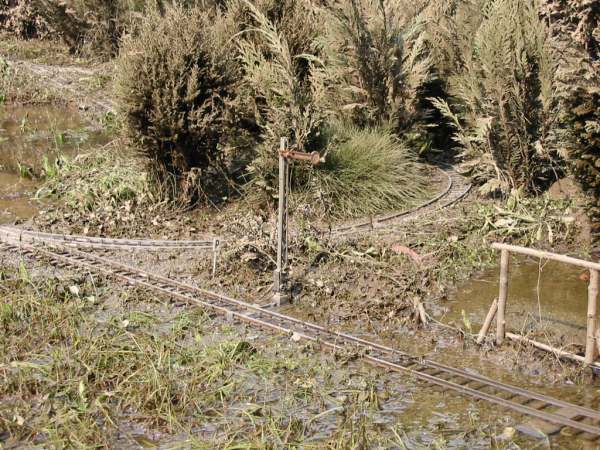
[239,0,326,192]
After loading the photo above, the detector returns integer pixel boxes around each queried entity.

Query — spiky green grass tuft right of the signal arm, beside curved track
[312,125,429,217]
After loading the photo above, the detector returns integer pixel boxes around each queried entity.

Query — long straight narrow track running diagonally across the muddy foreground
[0,241,600,440]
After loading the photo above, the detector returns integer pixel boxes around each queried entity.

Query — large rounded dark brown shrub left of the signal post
[116,6,252,200]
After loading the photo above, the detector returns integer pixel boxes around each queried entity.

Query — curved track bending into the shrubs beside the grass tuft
[331,166,471,236]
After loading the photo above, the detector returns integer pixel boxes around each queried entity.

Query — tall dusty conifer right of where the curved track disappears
[434,0,557,197]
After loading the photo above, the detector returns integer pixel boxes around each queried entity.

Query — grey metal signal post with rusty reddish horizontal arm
[273,138,323,306]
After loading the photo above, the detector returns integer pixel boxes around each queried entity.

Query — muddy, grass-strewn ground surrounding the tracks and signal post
[0,33,598,448]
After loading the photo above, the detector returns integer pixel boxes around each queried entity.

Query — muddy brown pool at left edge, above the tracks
[0,105,108,223]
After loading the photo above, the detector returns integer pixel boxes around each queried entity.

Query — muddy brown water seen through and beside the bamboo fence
[445,255,588,350]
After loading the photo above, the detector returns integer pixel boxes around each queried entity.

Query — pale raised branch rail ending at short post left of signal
[0,226,219,251]
